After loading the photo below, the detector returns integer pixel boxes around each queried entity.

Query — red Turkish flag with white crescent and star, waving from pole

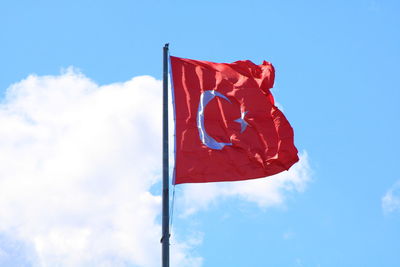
[170,56,299,184]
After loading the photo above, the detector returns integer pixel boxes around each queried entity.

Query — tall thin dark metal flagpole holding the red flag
[161,44,169,267]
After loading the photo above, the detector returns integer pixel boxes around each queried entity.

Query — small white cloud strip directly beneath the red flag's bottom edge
[177,151,311,216]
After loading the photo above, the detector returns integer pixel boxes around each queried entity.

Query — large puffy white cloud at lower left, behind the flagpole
[0,68,201,266]
